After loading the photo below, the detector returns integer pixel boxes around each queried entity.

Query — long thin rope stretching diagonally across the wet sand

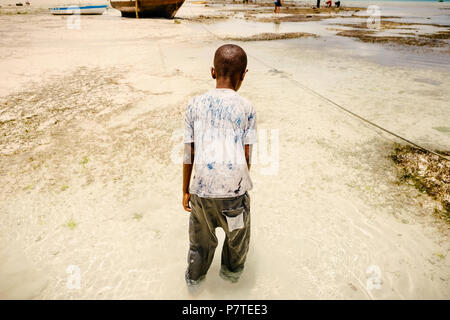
[185,9,450,161]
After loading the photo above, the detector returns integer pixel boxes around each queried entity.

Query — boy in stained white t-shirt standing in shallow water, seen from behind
[183,44,257,285]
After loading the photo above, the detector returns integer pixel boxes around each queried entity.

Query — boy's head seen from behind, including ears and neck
[211,44,247,91]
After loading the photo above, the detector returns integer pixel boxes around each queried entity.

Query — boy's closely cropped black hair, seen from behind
[214,44,247,78]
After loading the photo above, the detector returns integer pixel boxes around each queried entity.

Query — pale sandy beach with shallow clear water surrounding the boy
[0,1,450,299]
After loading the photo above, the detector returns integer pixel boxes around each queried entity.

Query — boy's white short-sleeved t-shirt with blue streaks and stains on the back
[183,89,257,198]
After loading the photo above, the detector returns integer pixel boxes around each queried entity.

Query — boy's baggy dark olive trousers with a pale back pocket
[186,192,250,281]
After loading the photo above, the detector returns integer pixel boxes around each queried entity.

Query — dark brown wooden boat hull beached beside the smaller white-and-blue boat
[111,0,184,19]
